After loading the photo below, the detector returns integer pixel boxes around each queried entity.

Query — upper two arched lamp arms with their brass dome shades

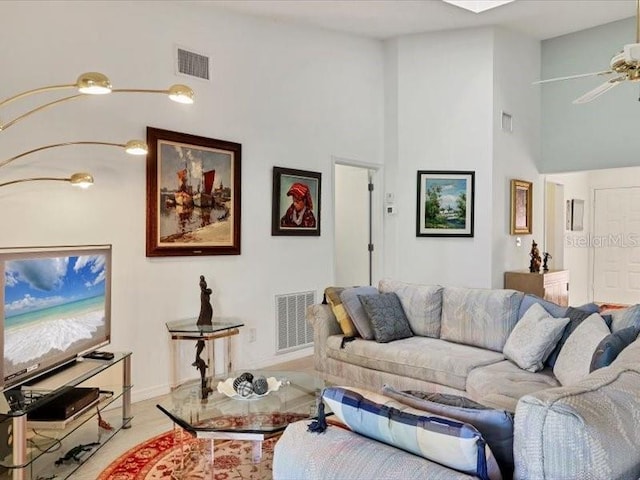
[0,72,194,131]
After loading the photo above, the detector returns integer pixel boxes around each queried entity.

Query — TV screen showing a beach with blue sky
[4,251,107,380]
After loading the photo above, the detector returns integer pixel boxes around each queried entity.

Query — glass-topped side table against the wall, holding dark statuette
[166,317,244,390]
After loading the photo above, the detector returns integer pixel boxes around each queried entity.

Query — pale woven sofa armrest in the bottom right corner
[514,363,640,480]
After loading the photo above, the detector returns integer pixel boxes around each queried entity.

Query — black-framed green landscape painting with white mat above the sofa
[416,170,475,237]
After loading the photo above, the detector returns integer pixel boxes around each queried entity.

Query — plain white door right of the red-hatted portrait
[334,163,371,287]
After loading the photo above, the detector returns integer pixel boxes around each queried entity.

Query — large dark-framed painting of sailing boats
[146,127,242,257]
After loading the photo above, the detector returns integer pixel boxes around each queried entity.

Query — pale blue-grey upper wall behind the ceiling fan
[533,19,640,173]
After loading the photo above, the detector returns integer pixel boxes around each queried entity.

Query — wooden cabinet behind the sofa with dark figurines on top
[504,270,569,307]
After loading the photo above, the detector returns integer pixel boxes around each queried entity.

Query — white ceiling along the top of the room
[200,0,636,42]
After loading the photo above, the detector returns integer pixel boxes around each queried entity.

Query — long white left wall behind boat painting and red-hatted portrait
[0,2,383,399]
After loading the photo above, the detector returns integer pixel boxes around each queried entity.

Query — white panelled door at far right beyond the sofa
[590,187,640,304]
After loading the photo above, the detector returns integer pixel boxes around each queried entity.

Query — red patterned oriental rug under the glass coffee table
[97,430,277,480]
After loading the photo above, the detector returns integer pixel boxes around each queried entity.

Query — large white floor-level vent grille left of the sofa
[276,291,316,353]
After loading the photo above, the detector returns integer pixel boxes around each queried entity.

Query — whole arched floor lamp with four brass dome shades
[0,72,194,188]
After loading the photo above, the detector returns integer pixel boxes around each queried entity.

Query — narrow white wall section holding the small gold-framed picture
[491,29,544,288]
